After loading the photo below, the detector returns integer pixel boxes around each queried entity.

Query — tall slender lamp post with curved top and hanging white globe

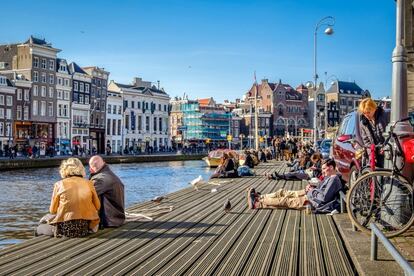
[313,16,335,145]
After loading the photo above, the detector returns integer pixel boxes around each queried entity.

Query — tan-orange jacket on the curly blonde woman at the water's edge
[50,176,101,229]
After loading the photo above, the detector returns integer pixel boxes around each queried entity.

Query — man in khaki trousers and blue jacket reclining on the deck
[247,159,342,213]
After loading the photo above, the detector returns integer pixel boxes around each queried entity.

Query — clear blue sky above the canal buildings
[0,0,396,102]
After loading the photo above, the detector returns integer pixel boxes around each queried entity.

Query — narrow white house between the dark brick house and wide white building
[105,91,123,154]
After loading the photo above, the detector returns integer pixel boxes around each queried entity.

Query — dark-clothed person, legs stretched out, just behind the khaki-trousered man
[267,153,322,180]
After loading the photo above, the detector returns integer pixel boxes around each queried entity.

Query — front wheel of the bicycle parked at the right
[347,170,414,238]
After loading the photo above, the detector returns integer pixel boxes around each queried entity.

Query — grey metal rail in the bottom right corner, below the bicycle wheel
[369,223,414,275]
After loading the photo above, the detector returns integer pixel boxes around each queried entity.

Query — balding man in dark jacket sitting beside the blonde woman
[89,155,125,227]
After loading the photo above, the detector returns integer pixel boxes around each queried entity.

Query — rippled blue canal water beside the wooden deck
[0,161,212,248]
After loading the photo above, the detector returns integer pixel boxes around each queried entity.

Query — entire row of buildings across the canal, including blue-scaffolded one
[0,36,368,154]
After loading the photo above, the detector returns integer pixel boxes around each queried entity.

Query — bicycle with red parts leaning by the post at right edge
[347,118,414,237]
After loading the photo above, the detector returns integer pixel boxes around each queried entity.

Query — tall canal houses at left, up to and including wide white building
[0,36,170,154]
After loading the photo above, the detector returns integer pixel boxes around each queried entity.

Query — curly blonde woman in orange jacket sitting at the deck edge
[36,158,101,238]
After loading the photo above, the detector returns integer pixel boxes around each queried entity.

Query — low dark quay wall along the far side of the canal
[0,154,206,171]
